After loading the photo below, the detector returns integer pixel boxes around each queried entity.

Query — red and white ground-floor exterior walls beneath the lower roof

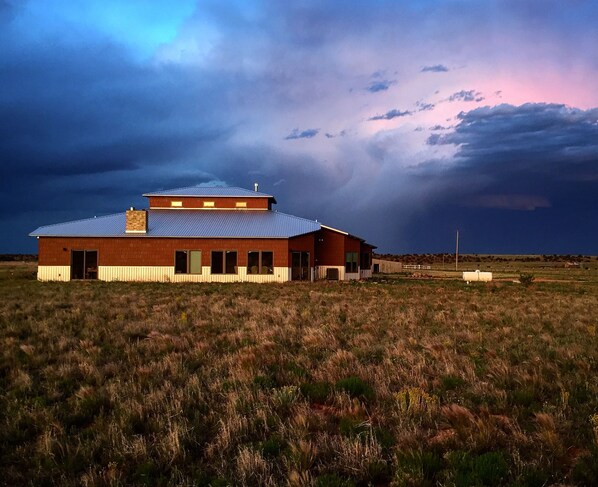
[38,229,371,282]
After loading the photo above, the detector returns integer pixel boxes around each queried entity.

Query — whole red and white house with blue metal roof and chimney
[30,184,375,282]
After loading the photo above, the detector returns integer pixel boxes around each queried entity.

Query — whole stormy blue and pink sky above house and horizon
[0,0,598,254]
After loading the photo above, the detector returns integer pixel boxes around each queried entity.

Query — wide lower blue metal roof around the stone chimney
[30,209,320,238]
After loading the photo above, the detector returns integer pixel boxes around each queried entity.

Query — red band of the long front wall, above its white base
[38,235,290,267]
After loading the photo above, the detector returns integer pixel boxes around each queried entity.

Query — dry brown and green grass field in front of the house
[0,263,598,487]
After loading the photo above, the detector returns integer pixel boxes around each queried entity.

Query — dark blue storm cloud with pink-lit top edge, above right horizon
[420,103,598,252]
